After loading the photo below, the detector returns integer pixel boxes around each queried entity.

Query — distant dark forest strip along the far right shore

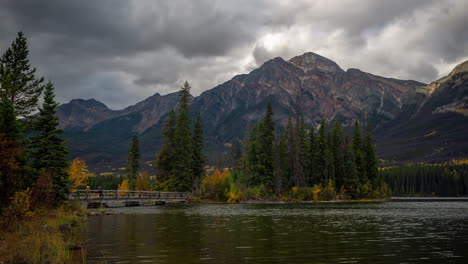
[379,160,468,196]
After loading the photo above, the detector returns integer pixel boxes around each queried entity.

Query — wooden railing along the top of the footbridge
[68,190,191,200]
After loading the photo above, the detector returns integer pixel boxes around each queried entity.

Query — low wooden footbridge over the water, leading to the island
[68,190,192,208]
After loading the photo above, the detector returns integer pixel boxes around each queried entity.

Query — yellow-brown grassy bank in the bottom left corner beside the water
[0,204,86,264]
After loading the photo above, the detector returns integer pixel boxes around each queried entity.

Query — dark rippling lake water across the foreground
[82,202,468,264]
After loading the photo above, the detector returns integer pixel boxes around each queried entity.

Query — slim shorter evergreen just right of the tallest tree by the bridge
[192,113,206,193]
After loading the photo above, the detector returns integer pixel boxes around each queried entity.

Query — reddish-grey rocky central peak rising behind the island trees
[193,53,425,143]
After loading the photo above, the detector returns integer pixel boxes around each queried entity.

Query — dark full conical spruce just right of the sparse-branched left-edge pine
[32,82,69,201]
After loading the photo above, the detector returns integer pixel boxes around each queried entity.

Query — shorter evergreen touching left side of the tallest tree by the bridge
[155,110,176,183]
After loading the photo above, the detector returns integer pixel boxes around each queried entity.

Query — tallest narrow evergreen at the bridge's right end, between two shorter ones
[168,82,193,192]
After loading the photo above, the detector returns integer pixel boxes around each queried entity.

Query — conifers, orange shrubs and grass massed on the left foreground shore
[0,32,86,263]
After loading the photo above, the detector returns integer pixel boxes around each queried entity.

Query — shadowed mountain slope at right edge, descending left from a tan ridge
[376,61,468,162]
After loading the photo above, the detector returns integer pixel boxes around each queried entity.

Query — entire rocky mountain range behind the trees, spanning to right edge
[58,53,468,170]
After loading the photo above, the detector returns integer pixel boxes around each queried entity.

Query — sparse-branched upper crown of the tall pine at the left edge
[0,32,44,117]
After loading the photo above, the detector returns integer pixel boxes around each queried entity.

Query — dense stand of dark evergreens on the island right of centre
[232,104,389,199]
